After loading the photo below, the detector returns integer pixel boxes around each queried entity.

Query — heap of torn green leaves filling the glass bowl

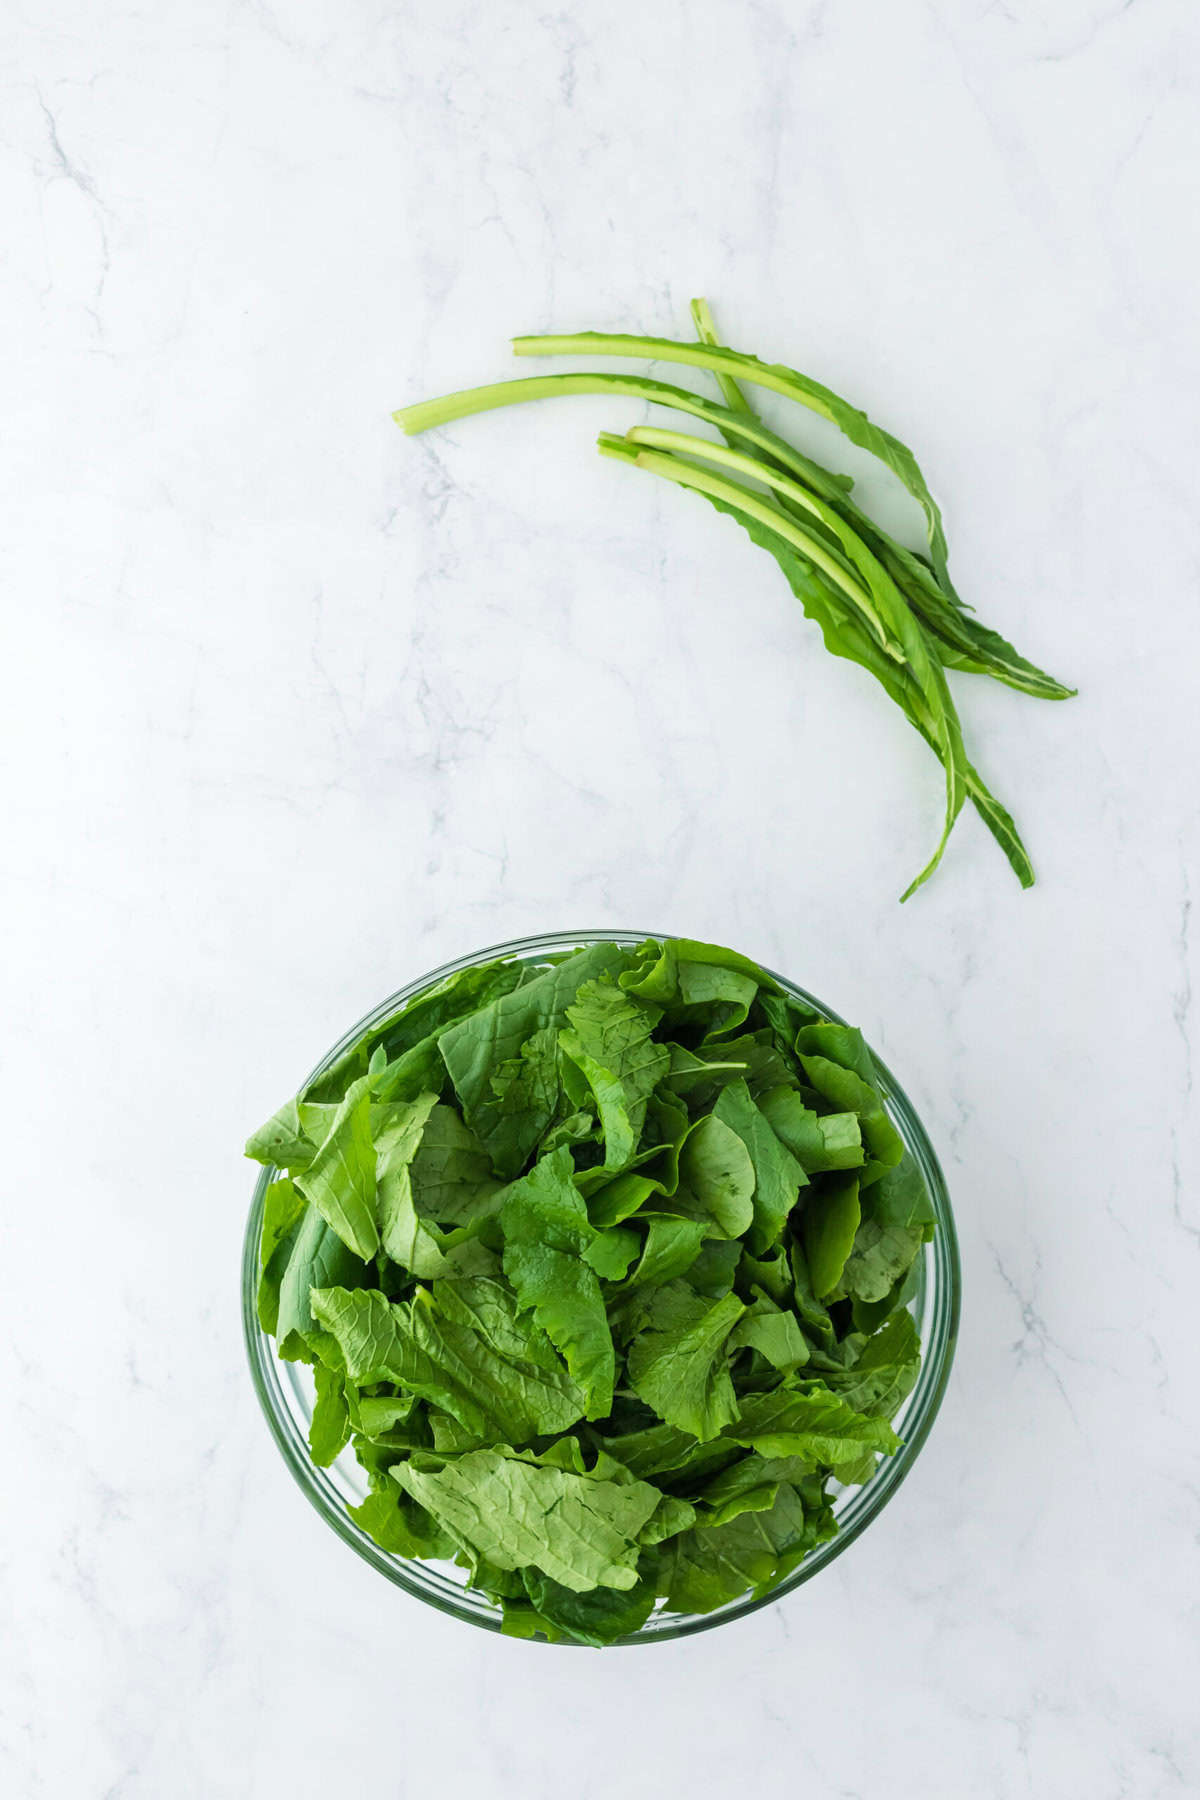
[246,938,934,1645]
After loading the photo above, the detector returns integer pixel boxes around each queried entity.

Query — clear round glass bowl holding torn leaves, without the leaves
[241,931,961,1643]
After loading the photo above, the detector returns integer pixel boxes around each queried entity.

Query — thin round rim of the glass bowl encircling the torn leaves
[241,931,963,1649]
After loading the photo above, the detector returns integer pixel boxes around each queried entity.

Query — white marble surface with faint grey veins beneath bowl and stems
[0,0,1200,1800]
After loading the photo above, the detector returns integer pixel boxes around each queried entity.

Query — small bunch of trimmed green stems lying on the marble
[395,301,1074,907]
